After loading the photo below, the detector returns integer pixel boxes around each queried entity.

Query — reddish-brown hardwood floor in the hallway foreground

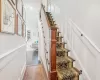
[23,64,48,80]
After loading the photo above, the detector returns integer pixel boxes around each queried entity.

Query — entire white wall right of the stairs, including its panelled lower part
[50,0,100,80]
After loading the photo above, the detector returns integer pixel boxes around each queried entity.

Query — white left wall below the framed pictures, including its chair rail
[0,33,26,80]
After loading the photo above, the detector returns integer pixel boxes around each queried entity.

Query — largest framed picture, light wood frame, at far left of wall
[0,0,16,34]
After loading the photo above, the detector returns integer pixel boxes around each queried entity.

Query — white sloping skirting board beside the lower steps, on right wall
[67,40,91,80]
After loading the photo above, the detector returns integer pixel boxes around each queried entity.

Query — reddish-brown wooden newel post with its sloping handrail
[41,5,57,80]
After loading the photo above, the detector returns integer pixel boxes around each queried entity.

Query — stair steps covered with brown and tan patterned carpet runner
[46,12,82,80]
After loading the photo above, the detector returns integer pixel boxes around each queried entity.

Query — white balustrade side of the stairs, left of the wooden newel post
[38,8,51,79]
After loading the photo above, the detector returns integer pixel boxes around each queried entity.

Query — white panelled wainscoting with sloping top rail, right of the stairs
[60,19,100,80]
